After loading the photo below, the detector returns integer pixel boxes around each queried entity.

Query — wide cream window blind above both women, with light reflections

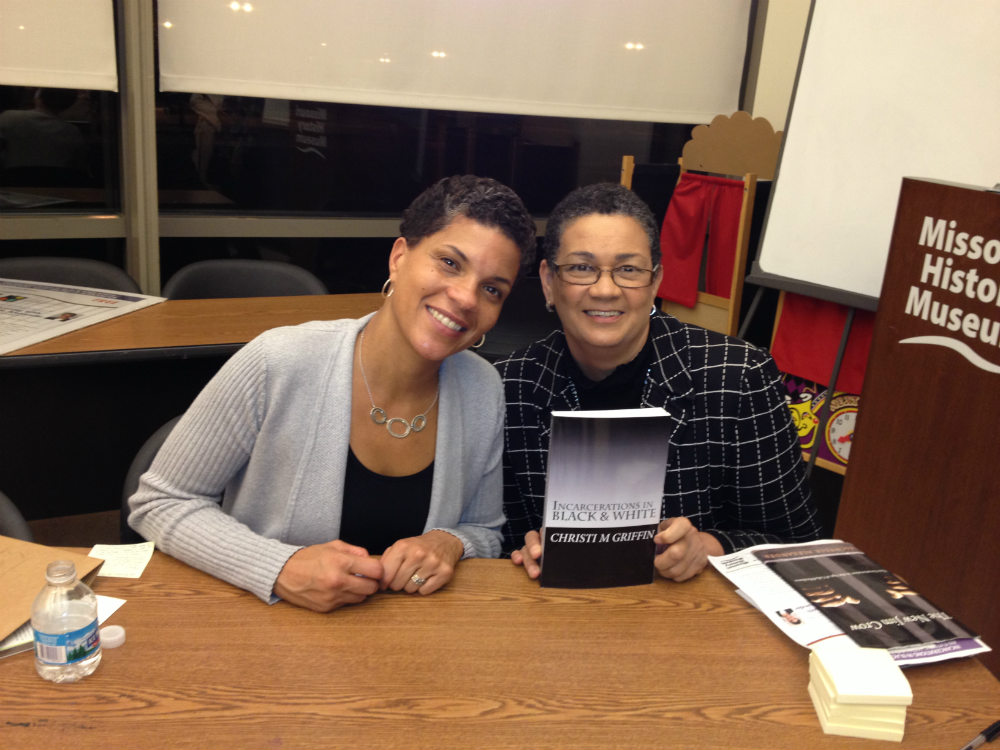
[158,0,750,123]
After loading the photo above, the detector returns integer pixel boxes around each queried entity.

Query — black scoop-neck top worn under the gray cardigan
[340,449,434,555]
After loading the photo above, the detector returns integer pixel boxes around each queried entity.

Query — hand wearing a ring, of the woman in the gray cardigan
[382,529,465,594]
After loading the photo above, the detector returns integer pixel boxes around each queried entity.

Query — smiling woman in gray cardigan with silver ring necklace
[135,176,535,611]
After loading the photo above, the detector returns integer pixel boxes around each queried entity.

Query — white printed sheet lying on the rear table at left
[0,279,164,354]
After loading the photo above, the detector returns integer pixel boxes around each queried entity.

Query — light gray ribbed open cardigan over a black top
[129,316,504,601]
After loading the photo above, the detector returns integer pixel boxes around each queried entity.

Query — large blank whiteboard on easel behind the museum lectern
[751,0,1000,306]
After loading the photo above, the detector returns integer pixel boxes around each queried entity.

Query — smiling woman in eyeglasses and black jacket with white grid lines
[496,183,819,581]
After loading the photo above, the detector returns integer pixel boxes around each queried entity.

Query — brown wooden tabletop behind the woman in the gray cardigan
[0,293,382,367]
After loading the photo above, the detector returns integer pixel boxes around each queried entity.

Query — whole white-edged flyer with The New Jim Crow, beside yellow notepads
[709,539,991,667]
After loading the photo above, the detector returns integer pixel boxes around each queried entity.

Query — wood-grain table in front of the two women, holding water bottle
[0,552,1000,750]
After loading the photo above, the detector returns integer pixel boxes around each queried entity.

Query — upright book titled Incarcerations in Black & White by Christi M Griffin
[540,408,670,588]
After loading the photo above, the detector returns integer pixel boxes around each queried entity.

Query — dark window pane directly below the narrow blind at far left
[0,86,121,212]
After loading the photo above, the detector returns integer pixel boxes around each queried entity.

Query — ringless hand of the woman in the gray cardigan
[274,539,383,612]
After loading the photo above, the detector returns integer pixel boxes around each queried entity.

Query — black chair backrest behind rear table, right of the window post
[163,258,329,299]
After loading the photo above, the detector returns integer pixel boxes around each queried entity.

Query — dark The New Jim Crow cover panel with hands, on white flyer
[754,542,978,648]
